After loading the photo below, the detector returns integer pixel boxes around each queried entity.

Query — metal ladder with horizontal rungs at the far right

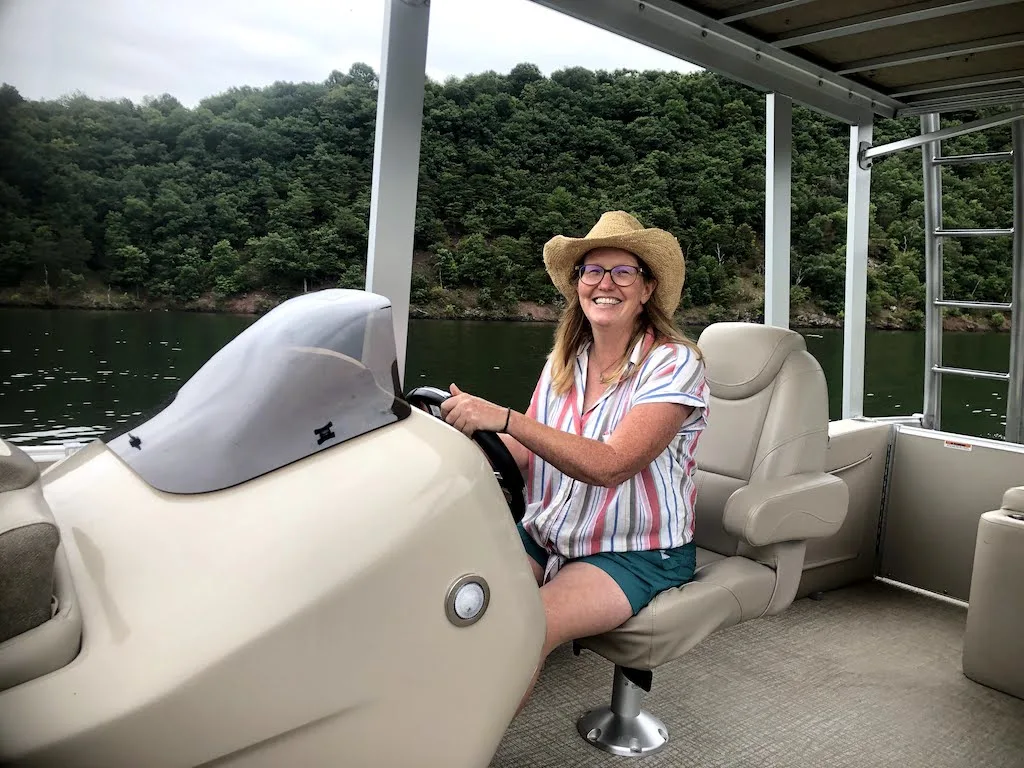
[921,114,1024,442]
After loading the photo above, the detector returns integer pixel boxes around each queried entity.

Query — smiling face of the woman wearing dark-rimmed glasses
[577,248,656,329]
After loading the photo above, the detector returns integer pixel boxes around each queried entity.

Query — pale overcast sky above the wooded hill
[0,0,697,106]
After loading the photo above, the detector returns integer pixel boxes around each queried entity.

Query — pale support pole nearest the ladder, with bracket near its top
[843,123,873,419]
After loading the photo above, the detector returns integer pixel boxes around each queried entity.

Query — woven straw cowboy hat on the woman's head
[544,211,686,317]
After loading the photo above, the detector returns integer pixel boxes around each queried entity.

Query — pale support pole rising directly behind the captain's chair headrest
[765,93,793,328]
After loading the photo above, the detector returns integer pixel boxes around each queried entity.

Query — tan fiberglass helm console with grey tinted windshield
[0,291,544,768]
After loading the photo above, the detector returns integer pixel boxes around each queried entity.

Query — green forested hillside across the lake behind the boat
[0,65,1013,327]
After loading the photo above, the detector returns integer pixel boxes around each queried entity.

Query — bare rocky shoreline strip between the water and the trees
[0,288,1010,333]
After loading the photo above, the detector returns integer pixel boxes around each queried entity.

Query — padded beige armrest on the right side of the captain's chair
[722,472,850,547]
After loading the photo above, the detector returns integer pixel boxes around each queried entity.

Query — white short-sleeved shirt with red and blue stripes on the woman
[522,335,708,579]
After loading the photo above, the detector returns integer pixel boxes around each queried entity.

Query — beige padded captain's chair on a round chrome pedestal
[577,323,849,755]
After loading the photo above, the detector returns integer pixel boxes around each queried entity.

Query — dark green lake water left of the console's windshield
[0,309,254,444]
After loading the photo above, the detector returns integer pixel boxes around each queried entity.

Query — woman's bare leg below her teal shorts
[516,562,633,715]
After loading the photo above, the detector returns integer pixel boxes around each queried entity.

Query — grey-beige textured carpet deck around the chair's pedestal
[492,583,1024,768]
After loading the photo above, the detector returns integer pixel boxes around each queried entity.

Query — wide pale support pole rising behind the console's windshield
[367,0,430,381]
